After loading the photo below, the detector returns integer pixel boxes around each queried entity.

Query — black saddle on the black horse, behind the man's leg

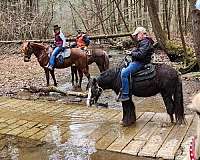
[131,64,156,82]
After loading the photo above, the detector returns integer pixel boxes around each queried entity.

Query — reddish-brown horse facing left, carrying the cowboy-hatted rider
[21,42,90,87]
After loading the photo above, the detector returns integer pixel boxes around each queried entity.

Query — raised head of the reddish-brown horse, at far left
[20,42,33,62]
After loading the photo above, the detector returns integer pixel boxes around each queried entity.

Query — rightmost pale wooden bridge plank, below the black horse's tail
[156,115,194,159]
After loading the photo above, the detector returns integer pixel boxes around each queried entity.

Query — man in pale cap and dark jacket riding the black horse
[118,27,154,101]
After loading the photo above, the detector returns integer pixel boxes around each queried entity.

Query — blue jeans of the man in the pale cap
[121,61,144,95]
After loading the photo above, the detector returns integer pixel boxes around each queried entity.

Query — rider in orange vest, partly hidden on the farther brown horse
[71,29,90,50]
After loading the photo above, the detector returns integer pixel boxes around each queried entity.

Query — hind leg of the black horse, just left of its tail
[161,92,174,123]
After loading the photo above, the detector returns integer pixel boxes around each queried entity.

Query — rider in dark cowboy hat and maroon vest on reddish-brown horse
[46,25,66,70]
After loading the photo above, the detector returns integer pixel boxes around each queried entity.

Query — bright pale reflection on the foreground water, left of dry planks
[45,124,96,160]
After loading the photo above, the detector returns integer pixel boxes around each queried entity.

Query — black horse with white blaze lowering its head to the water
[87,64,185,126]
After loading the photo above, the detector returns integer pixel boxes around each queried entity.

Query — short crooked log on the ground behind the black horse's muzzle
[22,86,87,98]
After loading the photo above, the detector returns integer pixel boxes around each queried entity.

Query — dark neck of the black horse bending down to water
[97,68,121,94]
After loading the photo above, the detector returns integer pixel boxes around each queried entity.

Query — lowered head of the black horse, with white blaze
[87,78,103,107]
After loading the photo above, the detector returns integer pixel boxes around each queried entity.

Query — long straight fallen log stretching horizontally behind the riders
[0,32,132,44]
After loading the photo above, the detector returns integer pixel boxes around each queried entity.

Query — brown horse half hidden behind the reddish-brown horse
[71,49,109,85]
